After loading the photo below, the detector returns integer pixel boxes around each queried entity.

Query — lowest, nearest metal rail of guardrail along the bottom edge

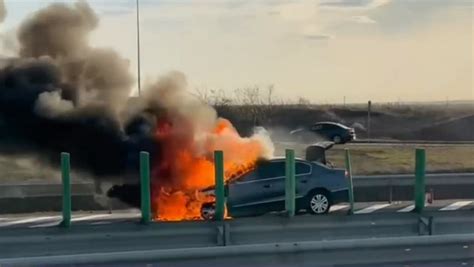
[0,234,474,266]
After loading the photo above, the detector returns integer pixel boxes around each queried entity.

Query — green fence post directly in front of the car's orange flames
[214,151,225,221]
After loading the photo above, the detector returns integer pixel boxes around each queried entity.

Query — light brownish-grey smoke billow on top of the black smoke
[18,1,134,113]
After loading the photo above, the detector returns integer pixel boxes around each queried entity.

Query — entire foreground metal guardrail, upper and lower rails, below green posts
[0,212,474,266]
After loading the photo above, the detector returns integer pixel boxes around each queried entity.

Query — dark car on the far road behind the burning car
[290,122,356,144]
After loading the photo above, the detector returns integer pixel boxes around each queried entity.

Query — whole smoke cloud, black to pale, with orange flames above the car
[0,1,273,213]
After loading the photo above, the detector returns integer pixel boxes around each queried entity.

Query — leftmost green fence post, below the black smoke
[60,152,71,228]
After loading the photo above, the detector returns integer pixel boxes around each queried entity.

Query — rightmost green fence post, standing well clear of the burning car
[414,148,426,213]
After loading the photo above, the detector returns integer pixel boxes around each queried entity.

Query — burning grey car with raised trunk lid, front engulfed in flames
[107,142,348,220]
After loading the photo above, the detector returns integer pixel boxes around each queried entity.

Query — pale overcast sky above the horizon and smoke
[1,0,474,103]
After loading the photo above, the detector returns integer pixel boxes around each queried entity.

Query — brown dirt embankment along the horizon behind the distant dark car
[216,105,474,141]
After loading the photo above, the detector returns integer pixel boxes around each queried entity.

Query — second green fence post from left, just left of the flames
[140,151,151,224]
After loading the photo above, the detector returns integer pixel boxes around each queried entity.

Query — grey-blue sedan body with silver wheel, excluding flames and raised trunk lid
[201,159,348,219]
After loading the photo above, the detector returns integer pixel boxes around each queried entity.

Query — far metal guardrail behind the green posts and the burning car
[0,173,474,213]
